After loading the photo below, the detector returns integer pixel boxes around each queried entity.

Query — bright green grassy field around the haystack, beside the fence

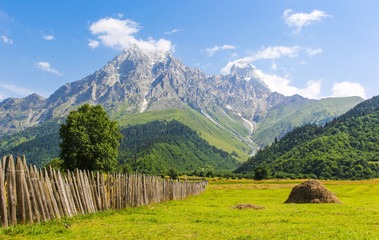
[0,179,379,239]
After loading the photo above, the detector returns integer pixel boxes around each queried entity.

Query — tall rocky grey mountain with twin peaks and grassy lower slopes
[0,46,362,164]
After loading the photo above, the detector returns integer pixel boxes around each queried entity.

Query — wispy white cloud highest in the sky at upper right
[283,9,331,33]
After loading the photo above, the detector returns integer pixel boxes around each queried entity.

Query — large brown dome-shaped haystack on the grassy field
[285,180,342,203]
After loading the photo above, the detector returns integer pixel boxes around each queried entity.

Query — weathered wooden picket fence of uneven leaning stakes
[0,155,208,228]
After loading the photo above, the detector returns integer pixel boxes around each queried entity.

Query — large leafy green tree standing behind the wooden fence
[59,104,123,171]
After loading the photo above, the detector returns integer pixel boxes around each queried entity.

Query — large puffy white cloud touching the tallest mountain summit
[88,18,173,52]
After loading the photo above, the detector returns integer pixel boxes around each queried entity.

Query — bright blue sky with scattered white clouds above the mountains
[0,0,379,101]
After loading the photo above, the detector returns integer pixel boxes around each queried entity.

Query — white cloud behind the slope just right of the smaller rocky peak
[256,69,321,99]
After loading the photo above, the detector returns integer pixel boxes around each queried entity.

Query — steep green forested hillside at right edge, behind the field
[235,96,379,179]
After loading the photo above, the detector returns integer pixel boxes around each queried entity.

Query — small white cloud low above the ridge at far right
[332,81,366,98]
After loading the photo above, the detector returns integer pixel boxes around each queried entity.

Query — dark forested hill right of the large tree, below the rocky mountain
[118,120,239,174]
